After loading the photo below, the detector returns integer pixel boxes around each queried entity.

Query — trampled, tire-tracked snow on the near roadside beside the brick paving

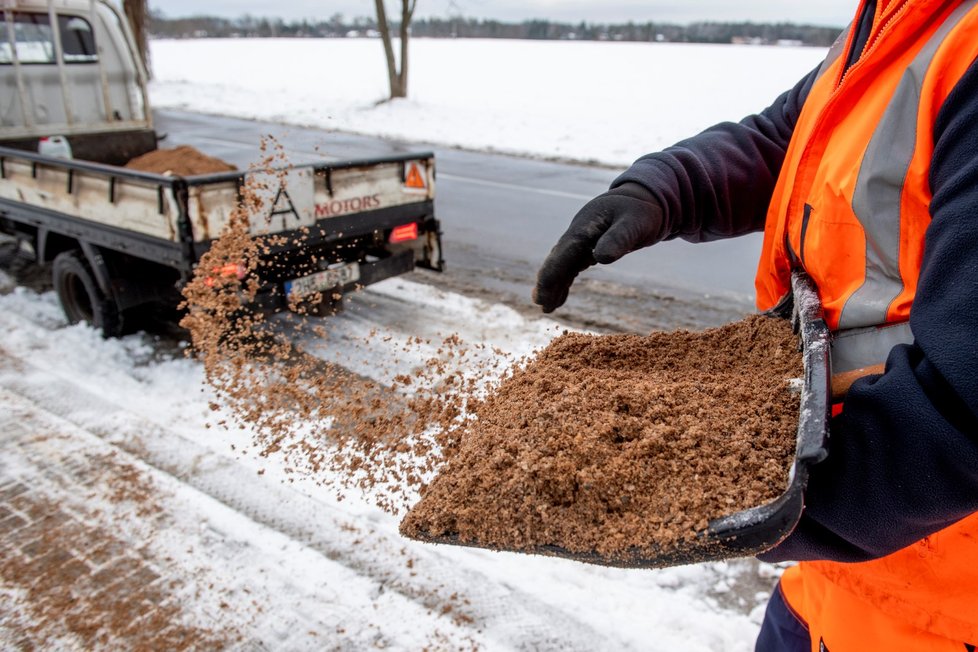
[0,272,777,651]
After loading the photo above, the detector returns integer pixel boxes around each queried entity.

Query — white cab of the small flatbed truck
[0,0,156,165]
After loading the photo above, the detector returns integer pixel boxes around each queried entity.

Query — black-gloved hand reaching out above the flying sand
[533,182,669,312]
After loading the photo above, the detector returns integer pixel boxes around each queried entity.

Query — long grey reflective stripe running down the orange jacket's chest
[839,0,978,329]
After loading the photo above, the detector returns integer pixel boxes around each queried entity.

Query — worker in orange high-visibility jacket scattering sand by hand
[534,0,978,652]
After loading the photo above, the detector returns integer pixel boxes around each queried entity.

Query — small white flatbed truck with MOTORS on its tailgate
[0,0,444,336]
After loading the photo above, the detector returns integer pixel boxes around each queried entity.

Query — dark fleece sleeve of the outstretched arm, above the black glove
[611,69,818,242]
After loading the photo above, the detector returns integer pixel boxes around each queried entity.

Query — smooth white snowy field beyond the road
[150,39,825,166]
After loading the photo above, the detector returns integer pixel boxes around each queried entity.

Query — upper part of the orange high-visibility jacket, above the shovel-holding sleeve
[756,0,978,336]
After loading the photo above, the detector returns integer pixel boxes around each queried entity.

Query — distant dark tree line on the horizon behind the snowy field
[149,12,841,46]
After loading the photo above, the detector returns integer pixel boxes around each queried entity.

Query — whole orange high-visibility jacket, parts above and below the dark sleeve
[756,0,978,649]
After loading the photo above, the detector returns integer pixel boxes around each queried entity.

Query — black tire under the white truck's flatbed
[51,251,122,337]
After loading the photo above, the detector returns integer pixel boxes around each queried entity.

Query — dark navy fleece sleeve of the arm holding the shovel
[761,62,978,561]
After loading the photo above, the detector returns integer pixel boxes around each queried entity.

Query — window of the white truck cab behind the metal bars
[0,12,98,64]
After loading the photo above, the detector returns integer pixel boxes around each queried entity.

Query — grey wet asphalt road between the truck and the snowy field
[156,110,761,332]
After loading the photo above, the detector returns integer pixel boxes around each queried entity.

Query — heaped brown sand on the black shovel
[401,316,803,557]
